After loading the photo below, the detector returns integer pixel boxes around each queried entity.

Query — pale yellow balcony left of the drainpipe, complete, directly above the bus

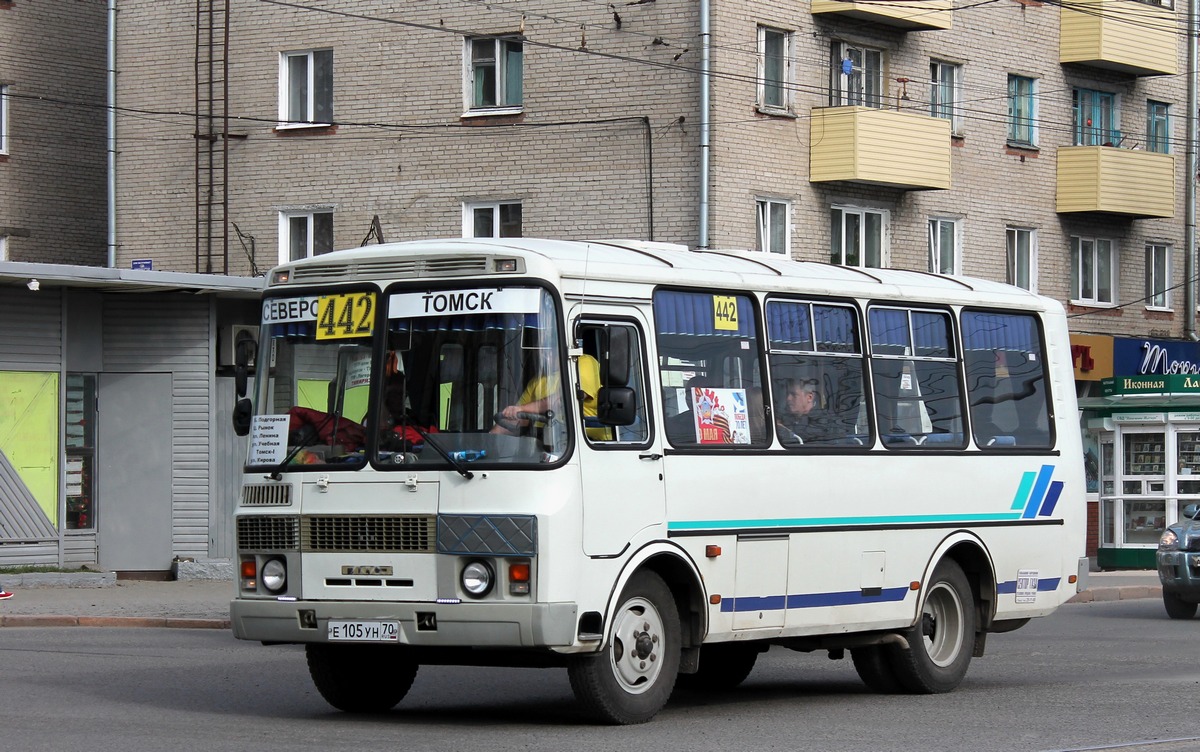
[809,107,950,191]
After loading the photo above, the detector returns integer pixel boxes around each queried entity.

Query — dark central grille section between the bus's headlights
[300,515,437,553]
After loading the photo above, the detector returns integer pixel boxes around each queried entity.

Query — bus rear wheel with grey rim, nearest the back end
[886,559,978,694]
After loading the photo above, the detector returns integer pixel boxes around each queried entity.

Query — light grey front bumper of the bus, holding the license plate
[229,598,578,648]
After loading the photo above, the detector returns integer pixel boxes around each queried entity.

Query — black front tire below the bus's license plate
[305,643,419,712]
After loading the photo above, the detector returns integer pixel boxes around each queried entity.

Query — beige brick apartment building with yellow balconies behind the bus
[0,0,1200,573]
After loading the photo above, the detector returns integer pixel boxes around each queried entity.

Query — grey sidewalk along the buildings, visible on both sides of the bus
[0,571,1163,630]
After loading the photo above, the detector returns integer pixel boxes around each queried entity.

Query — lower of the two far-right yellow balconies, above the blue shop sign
[1056,146,1175,218]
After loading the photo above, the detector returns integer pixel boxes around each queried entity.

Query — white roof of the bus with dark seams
[272,237,1061,309]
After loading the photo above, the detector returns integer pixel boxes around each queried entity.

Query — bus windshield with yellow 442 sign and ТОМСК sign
[247,287,566,471]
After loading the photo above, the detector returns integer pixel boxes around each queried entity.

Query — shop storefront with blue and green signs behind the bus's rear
[1073,337,1200,568]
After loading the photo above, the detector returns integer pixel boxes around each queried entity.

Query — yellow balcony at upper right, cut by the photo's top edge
[1058,0,1183,76]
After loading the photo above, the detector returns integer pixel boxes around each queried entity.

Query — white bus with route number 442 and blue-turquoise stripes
[230,239,1087,723]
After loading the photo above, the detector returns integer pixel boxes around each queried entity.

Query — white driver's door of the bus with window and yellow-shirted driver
[572,314,666,557]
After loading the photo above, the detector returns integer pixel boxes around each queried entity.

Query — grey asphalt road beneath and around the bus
[0,598,1200,752]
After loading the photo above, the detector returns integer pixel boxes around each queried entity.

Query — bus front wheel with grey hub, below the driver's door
[568,571,680,726]
